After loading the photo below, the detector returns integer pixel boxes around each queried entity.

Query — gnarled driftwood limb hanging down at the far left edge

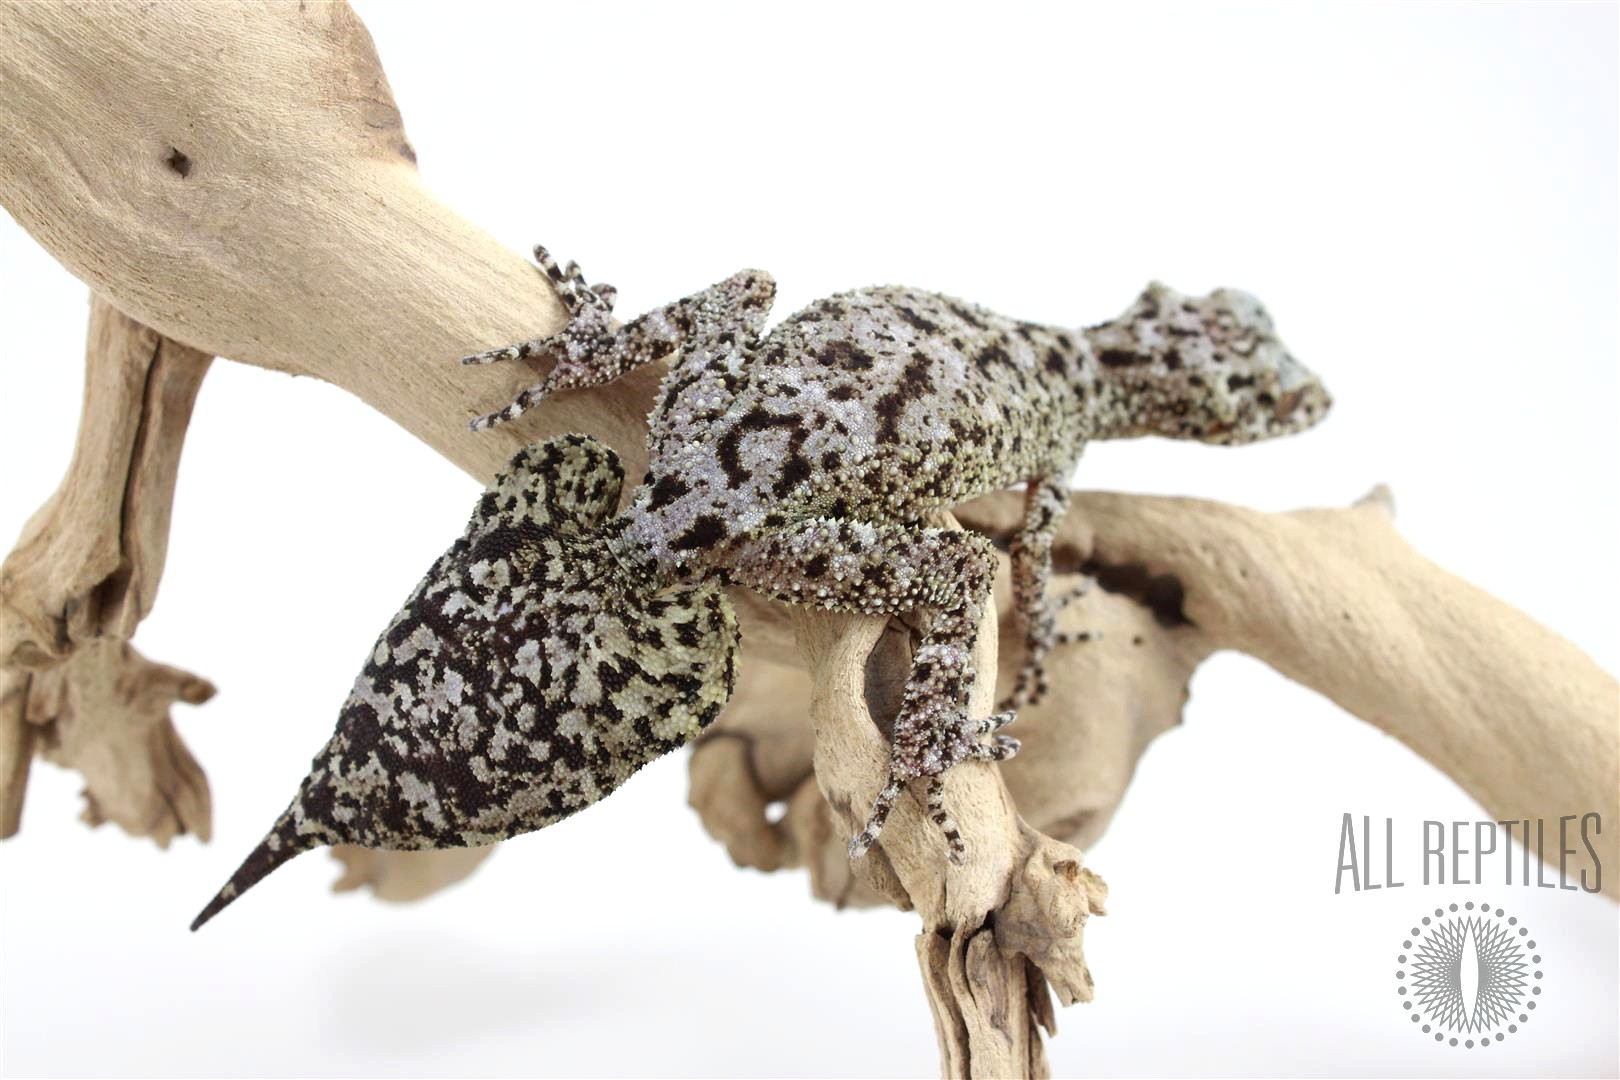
[0,300,214,845]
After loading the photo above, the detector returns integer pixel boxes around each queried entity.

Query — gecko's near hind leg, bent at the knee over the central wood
[726,518,1017,863]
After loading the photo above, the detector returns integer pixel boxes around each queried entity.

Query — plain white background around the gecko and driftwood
[0,3,1620,1075]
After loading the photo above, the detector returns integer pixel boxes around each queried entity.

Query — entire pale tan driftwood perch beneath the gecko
[0,3,1620,1075]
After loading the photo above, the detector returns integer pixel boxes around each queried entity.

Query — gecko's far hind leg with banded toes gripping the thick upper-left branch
[462,248,776,431]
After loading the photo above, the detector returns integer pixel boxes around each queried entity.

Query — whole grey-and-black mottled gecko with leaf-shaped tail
[193,248,1332,929]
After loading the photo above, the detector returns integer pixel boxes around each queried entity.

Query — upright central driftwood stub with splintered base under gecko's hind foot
[795,518,1106,1077]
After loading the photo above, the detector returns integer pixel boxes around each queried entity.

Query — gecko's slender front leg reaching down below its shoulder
[1000,473,1098,709]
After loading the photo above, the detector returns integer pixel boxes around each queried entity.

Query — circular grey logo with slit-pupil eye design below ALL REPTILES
[1395,902,1542,1049]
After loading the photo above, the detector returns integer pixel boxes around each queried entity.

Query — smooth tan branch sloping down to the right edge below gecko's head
[1043,489,1620,897]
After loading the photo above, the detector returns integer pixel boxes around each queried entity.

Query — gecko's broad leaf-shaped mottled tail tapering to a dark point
[193,436,739,929]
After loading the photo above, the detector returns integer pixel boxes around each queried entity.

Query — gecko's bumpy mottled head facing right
[1087,282,1333,445]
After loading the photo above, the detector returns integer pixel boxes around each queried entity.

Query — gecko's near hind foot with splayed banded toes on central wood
[849,708,1019,866]
